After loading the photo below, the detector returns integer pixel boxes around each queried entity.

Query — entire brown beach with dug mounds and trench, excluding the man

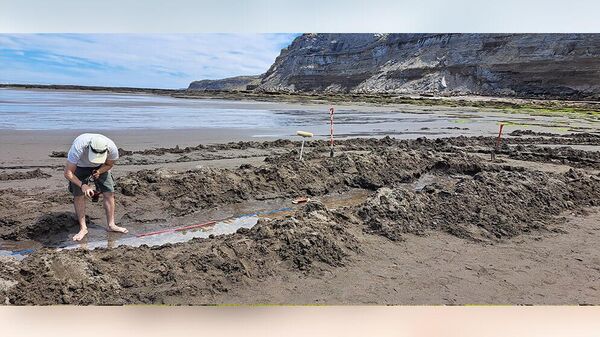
[0,104,600,304]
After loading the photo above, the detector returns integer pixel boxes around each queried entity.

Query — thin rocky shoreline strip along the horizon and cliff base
[0,84,600,115]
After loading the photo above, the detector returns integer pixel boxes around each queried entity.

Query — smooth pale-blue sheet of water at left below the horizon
[0,89,286,130]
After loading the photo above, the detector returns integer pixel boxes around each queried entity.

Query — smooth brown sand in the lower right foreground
[218,209,600,305]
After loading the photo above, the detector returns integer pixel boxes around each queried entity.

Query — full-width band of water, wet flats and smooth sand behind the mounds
[0,89,600,167]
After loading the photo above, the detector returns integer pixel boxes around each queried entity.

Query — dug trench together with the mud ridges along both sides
[2,137,600,304]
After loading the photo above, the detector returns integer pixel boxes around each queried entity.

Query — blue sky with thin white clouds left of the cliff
[0,33,298,88]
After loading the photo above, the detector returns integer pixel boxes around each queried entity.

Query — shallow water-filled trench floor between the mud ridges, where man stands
[0,189,372,259]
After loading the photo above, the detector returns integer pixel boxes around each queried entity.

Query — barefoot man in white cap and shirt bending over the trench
[65,133,127,241]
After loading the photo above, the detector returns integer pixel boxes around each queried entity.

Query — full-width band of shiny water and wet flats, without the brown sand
[0,89,598,138]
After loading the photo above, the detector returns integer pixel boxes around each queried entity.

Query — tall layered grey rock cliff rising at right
[257,34,600,99]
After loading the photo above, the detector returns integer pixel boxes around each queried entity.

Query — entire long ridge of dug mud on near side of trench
[5,165,600,304]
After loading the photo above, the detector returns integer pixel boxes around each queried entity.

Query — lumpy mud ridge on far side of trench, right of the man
[118,148,446,215]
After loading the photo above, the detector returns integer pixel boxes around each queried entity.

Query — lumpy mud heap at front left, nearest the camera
[8,203,359,304]
